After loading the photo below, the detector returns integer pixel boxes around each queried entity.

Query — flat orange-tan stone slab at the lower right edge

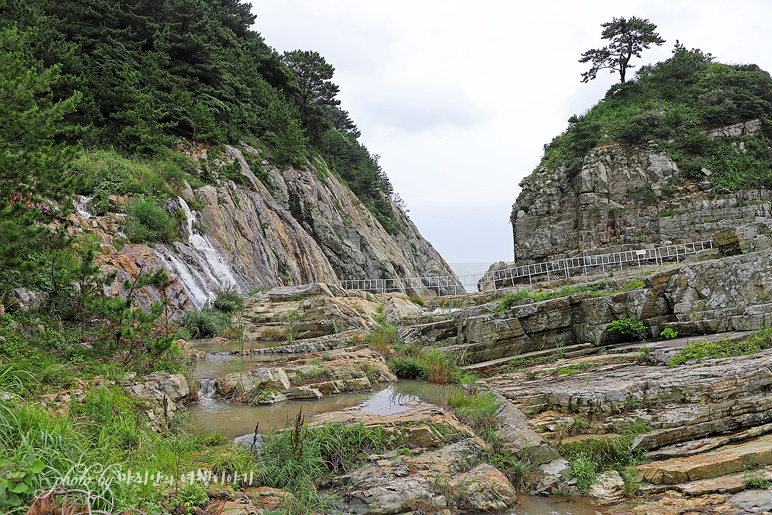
[636,434,772,485]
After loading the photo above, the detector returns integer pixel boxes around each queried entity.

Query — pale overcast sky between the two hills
[251,0,772,263]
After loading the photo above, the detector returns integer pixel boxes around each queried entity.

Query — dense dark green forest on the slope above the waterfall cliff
[0,0,396,232]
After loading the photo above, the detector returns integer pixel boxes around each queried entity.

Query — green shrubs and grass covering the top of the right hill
[539,43,772,189]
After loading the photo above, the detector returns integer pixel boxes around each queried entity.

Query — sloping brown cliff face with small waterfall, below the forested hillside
[70,146,453,309]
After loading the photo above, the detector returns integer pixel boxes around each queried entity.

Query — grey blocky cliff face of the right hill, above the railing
[511,120,772,265]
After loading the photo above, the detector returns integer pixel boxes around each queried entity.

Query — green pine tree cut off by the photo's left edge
[0,28,79,298]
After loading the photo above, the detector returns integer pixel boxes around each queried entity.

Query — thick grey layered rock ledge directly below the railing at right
[400,250,772,363]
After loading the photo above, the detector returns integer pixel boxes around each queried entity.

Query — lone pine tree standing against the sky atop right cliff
[579,16,665,84]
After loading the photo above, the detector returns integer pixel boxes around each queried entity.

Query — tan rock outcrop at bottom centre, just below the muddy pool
[310,406,517,515]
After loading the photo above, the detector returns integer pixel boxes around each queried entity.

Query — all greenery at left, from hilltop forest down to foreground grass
[0,0,416,514]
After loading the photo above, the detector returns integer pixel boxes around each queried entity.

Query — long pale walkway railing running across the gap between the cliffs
[338,240,713,295]
